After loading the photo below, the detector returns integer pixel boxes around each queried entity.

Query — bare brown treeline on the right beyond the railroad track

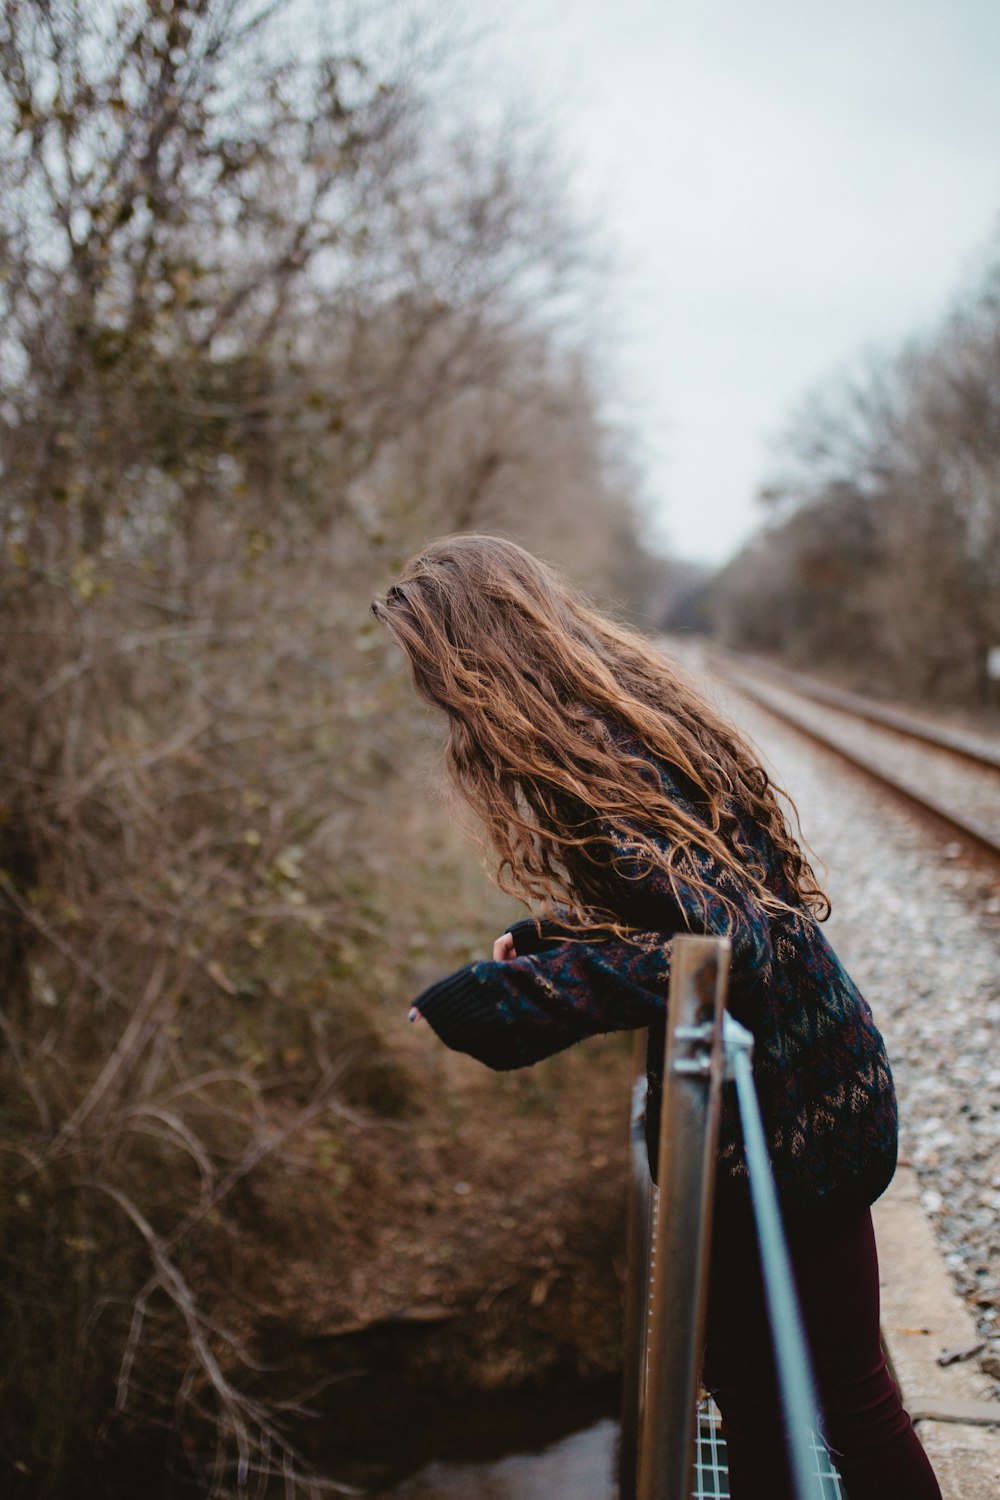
[712,251,1000,707]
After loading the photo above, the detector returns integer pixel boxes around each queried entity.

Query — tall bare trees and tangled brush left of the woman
[0,0,653,1496]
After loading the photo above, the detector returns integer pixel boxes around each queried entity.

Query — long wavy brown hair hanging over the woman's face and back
[372,536,829,932]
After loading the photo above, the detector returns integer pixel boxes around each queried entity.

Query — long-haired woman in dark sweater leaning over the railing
[372,536,940,1500]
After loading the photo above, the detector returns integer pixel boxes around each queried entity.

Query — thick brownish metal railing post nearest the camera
[637,936,729,1500]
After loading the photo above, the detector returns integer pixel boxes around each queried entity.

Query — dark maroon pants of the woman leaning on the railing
[705,1208,942,1500]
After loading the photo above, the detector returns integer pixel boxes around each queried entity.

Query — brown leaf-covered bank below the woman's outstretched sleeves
[259,1031,630,1362]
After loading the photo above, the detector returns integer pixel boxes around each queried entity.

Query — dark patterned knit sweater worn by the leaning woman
[414,750,897,1215]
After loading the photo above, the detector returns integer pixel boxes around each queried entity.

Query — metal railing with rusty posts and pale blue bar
[619,936,838,1500]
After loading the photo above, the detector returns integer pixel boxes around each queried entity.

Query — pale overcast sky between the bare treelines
[487,0,1000,563]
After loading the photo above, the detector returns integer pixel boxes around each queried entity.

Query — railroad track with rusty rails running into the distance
[711,653,1000,861]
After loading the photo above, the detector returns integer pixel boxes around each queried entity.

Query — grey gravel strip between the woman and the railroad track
[684,650,1000,1395]
